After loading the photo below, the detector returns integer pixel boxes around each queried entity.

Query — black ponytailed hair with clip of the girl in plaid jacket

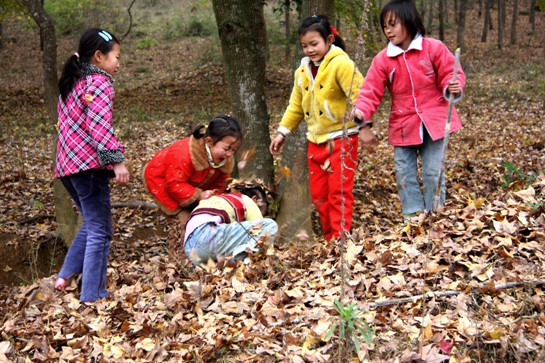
[59,28,119,101]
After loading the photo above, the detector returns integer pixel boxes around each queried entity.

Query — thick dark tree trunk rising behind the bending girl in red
[212,0,273,183]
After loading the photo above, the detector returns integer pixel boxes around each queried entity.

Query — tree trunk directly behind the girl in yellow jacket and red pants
[276,0,334,240]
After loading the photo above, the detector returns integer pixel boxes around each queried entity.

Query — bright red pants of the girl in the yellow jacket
[307,135,358,241]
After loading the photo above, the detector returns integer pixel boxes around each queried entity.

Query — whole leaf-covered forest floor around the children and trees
[0,0,545,362]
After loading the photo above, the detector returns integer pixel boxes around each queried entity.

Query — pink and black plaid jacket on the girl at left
[55,66,124,178]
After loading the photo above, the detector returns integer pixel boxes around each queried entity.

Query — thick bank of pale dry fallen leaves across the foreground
[0,176,545,362]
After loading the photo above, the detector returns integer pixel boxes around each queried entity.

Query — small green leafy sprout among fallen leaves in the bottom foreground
[325,300,375,354]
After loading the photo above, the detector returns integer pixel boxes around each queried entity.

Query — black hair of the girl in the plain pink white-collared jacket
[380,0,426,39]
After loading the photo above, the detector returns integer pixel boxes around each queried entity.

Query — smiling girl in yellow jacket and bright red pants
[269,15,363,240]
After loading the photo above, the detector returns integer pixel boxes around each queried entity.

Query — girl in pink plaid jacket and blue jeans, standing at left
[55,28,129,302]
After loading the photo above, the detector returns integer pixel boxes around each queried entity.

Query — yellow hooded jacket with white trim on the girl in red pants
[278,45,363,144]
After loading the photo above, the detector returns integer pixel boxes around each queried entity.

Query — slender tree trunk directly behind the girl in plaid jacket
[21,0,79,247]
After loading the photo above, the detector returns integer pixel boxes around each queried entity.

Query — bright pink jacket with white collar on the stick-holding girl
[355,34,465,146]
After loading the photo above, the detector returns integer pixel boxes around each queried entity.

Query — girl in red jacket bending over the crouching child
[144,115,242,256]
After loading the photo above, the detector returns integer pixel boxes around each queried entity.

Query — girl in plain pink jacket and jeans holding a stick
[355,0,465,219]
